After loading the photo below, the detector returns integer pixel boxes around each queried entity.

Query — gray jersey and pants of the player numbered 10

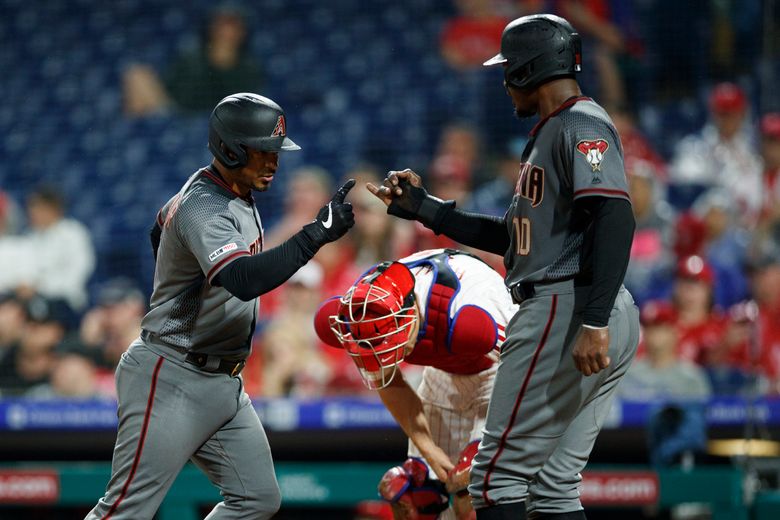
[469,97,639,517]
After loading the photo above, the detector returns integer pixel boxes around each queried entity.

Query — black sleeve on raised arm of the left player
[213,231,319,301]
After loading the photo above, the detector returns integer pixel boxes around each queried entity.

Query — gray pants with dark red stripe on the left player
[86,339,281,520]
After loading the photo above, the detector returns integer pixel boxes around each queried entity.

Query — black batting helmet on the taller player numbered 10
[484,14,582,89]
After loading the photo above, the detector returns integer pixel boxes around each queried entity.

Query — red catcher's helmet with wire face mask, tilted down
[314,262,418,389]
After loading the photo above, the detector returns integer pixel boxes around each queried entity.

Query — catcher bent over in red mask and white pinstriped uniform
[314,249,517,520]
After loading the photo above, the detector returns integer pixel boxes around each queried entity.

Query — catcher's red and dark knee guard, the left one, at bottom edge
[378,457,450,520]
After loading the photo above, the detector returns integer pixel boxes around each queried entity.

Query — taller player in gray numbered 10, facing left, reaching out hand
[367,15,639,520]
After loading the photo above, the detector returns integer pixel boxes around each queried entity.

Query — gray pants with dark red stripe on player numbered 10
[469,281,639,518]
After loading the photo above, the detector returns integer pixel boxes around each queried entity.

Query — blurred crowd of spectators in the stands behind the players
[0,0,780,399]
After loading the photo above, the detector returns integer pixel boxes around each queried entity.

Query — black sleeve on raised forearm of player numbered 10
[431,205,509,256]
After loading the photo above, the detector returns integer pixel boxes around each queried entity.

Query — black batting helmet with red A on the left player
[209,92,301,168]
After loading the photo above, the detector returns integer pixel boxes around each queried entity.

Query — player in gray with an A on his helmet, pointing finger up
[87,93,354,520]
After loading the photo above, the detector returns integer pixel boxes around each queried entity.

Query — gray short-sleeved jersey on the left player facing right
[142,168,263,357]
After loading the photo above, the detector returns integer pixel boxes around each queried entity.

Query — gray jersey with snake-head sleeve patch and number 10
[504,97,628,287]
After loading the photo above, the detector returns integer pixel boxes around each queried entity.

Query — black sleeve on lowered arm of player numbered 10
[575,197,636,327]
